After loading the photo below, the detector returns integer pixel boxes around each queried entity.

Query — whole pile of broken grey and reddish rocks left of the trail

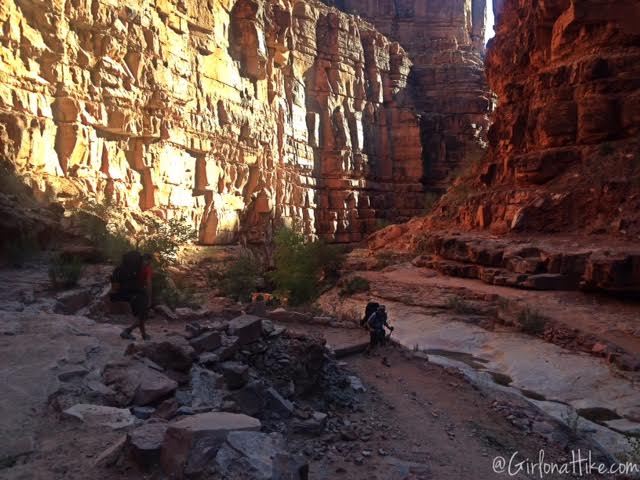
[54,315,358,480]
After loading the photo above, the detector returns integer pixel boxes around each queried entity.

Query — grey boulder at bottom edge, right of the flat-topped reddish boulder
[216,432,309,480]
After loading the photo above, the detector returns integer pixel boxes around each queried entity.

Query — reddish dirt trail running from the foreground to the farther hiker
[287,318,608,480]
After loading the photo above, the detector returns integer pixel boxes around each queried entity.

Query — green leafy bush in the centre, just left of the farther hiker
[269,226,343,305]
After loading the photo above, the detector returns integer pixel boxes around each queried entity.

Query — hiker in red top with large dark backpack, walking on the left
[109,250,153,340]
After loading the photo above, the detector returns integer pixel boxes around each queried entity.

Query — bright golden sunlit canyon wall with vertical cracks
[0,0,425,244]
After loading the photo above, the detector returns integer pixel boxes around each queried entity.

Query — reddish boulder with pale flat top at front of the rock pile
[160,412,262,479]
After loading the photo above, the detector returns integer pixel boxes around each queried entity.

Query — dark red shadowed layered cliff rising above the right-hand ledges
[425,0,640,239]
